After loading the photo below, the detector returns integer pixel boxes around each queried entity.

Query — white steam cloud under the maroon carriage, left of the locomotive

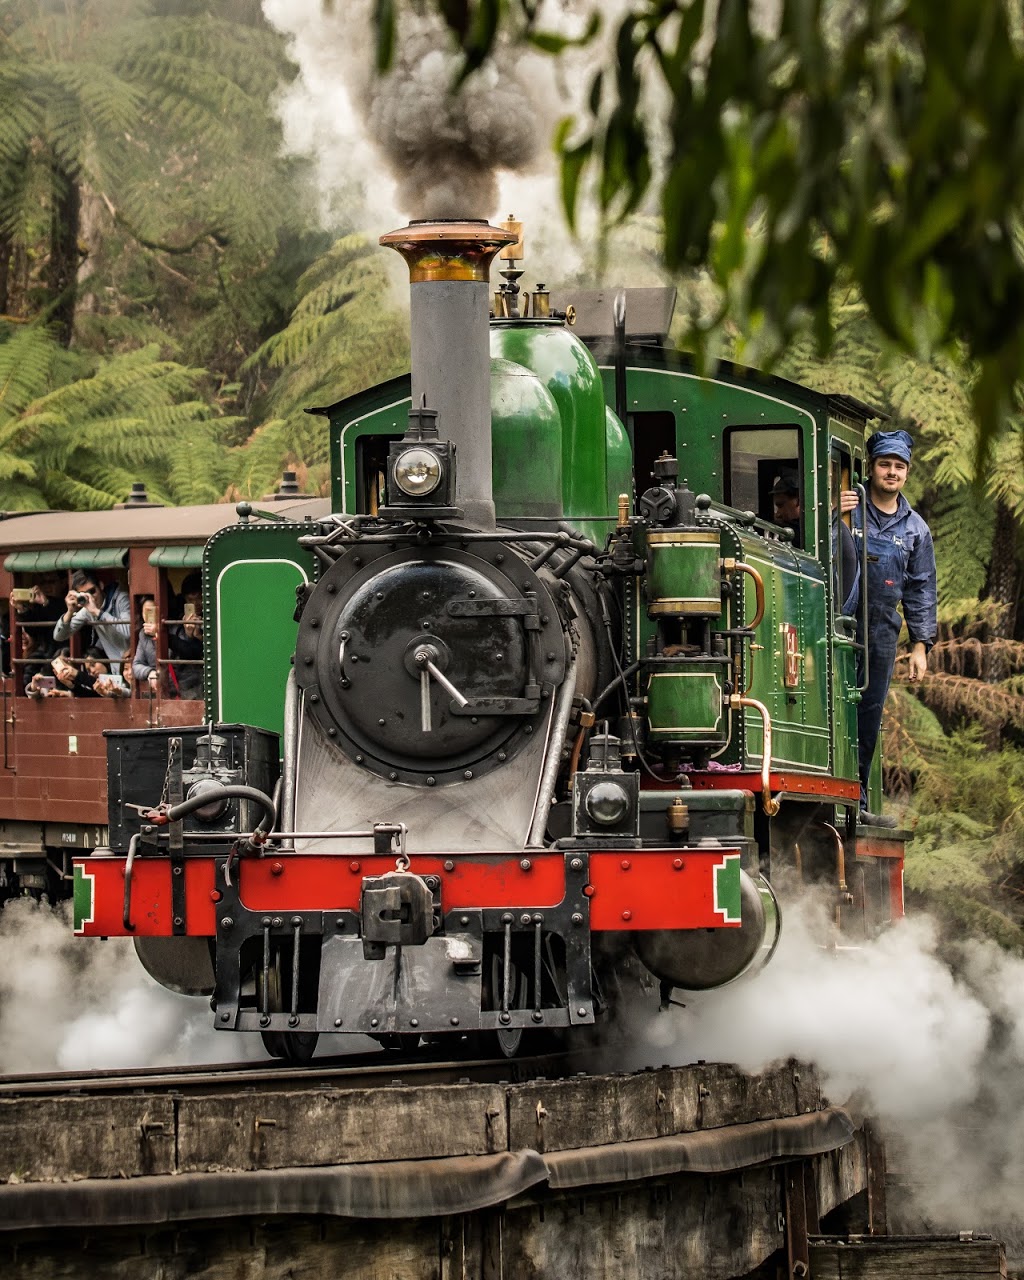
[0,899,266,1074]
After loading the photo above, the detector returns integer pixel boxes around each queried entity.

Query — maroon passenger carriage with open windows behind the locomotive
[0,481,328,904]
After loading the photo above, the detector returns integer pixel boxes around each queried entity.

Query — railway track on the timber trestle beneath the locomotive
[0,1051,611,1098]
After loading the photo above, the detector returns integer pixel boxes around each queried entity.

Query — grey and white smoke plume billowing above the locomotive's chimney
[264,0,567,218]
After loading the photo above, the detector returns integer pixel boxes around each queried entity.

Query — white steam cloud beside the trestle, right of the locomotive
[616,890,1024,1238]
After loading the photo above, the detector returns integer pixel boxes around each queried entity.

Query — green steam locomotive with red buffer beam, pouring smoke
[74,221,904,1060]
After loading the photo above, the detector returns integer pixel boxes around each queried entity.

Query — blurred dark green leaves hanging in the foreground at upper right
[378,0,1024,447]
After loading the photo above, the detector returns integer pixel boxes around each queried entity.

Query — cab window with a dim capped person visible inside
[726,426,805,547]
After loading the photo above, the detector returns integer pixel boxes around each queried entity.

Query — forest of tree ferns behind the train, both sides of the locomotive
[0,0,1024,950]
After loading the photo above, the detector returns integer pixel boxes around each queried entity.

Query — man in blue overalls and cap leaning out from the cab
[844,431,936,827]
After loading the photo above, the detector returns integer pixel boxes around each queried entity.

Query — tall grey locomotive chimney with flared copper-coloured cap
[380,220,516,530]
